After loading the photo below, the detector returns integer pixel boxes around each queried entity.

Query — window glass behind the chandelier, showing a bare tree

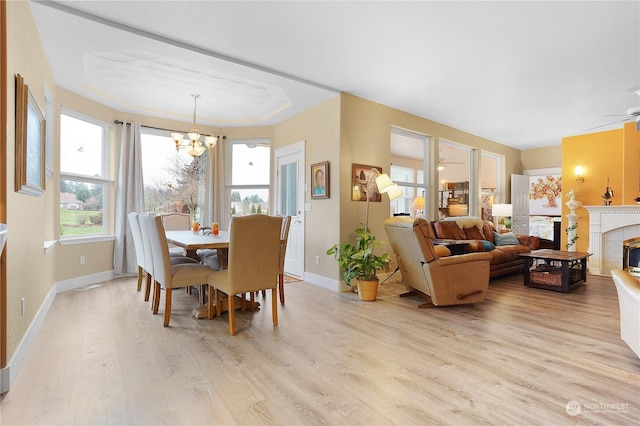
[141,128,209,220]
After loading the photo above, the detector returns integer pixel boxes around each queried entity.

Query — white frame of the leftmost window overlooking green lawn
[58,107,114,241]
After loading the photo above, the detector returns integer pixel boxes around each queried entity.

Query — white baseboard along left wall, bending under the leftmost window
[0,270,116,393]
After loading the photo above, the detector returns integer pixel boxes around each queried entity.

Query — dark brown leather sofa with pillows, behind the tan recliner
[416,217,531,278]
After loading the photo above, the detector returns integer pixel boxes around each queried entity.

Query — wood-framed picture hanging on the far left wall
[15,74,45,196]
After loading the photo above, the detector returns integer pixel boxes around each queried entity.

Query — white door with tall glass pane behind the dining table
[275,141,305,278]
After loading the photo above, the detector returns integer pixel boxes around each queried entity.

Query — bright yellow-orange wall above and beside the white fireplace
[562,123,640,252]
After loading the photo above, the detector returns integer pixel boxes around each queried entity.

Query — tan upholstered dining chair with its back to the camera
[208,214,282,335]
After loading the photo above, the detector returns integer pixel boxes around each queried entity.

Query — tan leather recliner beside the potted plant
[384,216,491,308]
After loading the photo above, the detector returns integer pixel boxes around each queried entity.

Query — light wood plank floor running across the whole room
[0,275,640,425]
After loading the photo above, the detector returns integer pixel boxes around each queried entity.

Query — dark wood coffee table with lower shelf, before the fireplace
[519,249,591,293]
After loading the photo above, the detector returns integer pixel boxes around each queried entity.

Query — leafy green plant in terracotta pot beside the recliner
[327,228,389,301]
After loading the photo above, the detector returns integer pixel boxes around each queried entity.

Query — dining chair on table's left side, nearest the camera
[142,215,211,327]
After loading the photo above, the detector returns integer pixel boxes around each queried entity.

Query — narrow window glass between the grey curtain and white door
[225,139,271,223]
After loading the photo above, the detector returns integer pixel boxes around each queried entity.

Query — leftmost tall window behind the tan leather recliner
[389,129,429,216]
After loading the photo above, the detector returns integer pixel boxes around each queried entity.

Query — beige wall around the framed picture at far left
[5,2,56,360]
